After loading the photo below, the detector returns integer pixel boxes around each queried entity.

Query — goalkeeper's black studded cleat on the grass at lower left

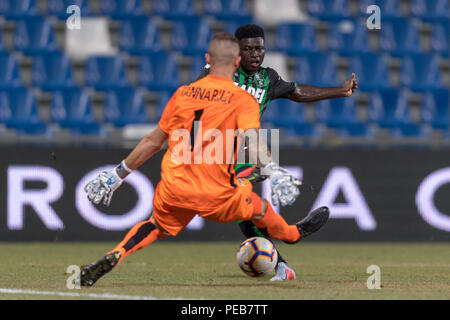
[80,252,121,287]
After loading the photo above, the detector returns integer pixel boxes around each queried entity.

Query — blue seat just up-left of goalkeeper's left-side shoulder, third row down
[138,51,181,91]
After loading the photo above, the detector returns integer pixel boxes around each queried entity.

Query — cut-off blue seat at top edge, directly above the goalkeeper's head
[204,0,251,20]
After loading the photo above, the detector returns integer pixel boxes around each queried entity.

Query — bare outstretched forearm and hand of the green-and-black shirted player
[288,73,358,102]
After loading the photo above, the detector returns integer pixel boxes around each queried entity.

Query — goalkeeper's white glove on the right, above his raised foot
[261,162,302,207]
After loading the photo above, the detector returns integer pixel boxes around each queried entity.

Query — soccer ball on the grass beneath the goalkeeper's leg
[236,237,278,277]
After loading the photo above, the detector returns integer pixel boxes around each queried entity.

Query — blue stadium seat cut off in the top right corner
[410,0,450,23]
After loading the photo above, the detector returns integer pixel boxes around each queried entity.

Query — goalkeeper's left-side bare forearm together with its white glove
[84,126,168,206]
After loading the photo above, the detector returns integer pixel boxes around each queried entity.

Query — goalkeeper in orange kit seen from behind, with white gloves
[80,33,329,286]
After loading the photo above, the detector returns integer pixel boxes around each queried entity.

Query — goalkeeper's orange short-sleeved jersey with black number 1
[157,75,260,212]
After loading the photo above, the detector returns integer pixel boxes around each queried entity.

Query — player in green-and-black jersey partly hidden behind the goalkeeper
[199,24,358,281]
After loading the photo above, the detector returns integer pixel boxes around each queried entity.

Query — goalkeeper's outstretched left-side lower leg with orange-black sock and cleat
[80,220,166,287]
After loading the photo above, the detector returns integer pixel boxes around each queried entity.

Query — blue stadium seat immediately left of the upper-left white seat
[14,16,56,55]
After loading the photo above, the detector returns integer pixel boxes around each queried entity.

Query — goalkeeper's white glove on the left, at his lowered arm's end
[84,161,131,206]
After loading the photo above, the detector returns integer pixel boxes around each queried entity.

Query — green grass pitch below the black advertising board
[0,241,450,300]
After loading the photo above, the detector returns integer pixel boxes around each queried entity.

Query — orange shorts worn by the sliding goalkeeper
[153,179,261,236]
